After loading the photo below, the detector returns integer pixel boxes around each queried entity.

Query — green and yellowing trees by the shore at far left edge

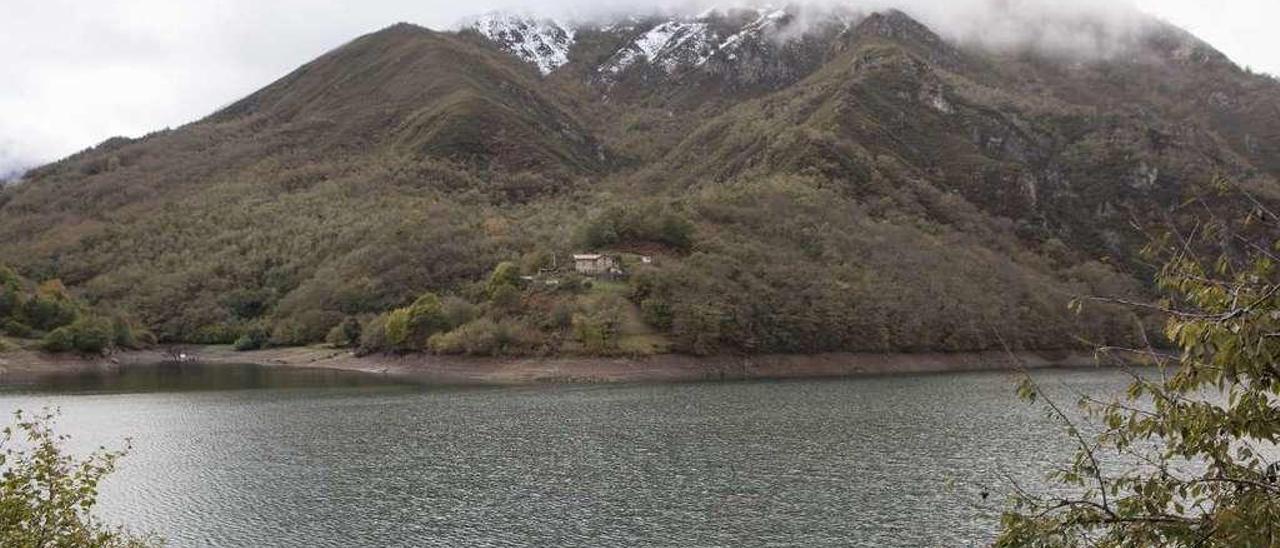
[0,265,155,353]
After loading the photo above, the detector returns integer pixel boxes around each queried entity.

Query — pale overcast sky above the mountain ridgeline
[0,0,1280,175]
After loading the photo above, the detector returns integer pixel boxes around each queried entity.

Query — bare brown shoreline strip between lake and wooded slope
[0,346,1097,385]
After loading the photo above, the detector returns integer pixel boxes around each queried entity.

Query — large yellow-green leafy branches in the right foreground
[996,185,1280,547]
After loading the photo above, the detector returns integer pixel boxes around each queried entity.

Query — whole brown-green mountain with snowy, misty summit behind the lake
[0,6,1280,353]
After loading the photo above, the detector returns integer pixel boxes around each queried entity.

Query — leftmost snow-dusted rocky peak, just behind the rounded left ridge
[462,12,576,74]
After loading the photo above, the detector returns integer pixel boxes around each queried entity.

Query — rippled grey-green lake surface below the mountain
[0,365,1125,547]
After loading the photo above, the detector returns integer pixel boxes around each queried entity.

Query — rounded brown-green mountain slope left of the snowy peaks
[0,24,600,339]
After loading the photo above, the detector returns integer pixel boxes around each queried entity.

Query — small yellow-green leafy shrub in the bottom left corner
[0,411,161,548]
